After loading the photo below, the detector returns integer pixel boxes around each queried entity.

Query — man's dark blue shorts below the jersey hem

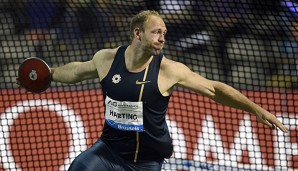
[68,140,163,171]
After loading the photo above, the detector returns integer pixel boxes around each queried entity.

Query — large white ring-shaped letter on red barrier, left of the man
[0,99,87,171]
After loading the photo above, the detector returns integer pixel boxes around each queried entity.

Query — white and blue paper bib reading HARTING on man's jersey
[105,96,144,132]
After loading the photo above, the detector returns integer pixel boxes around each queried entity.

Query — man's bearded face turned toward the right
[141,15,167,55]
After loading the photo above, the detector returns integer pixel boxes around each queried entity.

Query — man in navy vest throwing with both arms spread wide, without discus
[52,11,287,171]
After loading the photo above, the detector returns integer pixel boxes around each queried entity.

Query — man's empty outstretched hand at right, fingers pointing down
[256,112,288,133]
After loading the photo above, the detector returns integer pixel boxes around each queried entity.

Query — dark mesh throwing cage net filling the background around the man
[0,0,298,171]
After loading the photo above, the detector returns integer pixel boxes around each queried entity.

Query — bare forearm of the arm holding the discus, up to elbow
[51,62,79,84]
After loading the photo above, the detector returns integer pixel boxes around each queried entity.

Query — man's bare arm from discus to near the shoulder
[51,60,98,84]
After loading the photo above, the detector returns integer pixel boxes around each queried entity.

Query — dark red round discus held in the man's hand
[18,57,52,93]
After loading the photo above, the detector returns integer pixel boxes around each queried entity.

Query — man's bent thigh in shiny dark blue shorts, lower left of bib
[68,140,127,171]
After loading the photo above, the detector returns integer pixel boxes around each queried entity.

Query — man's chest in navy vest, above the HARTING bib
[101,46,160,102]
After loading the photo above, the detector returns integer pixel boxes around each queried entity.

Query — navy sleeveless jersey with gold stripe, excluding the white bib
[101,46,173,161]
